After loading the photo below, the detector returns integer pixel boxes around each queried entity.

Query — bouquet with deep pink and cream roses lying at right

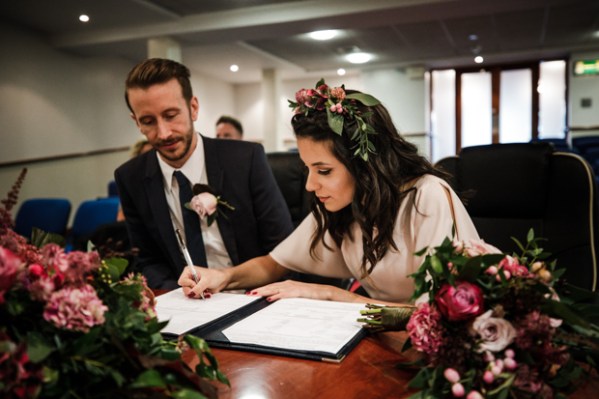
[360,231,599,399]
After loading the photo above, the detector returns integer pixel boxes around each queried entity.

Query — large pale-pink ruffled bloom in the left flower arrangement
[44,284,108,332]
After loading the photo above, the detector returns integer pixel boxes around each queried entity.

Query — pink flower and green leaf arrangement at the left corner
[0,169,228,399]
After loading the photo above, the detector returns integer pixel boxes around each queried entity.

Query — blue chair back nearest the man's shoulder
[67,197,119,251]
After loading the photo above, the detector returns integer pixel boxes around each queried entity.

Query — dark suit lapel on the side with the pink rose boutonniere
[201,136,239,265]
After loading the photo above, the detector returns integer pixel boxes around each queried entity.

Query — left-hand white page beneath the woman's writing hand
[156,288,259,335]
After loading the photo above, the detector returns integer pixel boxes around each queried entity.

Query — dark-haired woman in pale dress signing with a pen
[179,81,478,305]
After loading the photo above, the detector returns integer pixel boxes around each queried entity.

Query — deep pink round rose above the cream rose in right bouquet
[435,281,483,321]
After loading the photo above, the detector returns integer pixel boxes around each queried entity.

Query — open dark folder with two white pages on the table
[156,290,366,362]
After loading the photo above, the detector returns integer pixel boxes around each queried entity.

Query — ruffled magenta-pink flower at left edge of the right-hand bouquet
[406,302,444,355]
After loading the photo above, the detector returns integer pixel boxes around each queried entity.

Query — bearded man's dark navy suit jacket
[115,136,293,289]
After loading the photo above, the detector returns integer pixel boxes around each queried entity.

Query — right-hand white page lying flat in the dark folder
[223,298,365,354]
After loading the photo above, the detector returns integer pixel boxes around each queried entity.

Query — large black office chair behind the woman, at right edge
[437,143,599,290]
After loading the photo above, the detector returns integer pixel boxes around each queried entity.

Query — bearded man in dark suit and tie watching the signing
[115,58,293,289]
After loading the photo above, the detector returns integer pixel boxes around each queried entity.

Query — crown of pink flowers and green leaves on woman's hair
[288,79,381,161]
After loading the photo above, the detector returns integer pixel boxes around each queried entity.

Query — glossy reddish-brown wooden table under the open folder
[184,332,599,399]
